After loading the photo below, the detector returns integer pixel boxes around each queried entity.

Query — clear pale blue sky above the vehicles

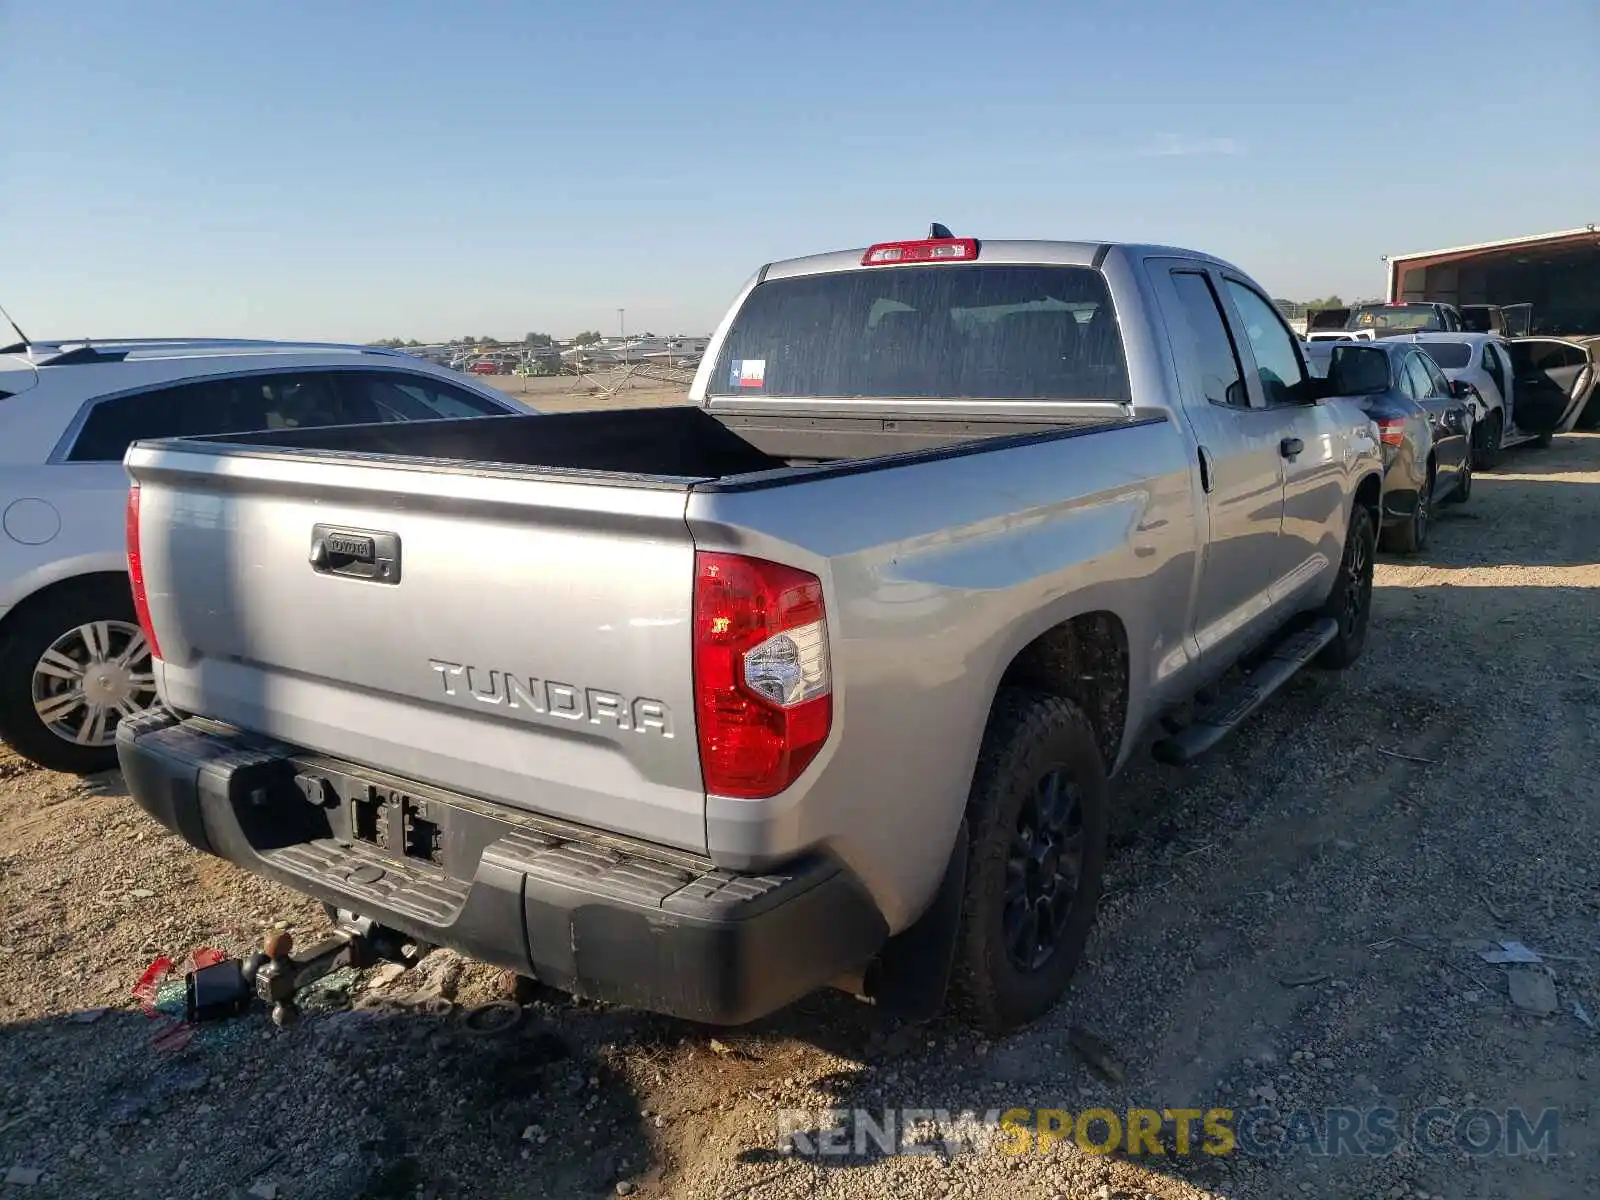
[0,0,1600,339]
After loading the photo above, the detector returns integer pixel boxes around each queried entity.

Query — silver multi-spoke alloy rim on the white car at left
[34,621,155,747]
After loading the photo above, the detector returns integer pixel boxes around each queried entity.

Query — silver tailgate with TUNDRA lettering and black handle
[126,445,706,851]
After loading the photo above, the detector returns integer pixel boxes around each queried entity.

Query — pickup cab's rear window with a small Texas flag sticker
[709,264,1130,400]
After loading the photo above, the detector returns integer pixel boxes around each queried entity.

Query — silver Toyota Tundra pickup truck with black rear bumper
[118,235,1381,1029]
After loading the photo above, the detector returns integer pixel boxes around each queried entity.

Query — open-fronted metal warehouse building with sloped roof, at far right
[1389,226,1600,334]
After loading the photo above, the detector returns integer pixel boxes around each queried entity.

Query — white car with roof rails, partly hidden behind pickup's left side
[0,339,531,773]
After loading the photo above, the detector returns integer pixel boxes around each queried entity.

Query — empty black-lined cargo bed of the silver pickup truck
[194,405,1128,486]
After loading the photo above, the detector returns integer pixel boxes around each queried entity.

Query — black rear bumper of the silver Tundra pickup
[117,712,886,1024]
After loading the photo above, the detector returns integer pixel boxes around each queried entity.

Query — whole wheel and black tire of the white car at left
[0,576,155,774]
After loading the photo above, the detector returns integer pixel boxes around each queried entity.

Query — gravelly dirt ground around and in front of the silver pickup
[0,435,1600,1200]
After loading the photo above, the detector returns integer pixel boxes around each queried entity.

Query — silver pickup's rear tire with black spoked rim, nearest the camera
[950,688,1109,1034]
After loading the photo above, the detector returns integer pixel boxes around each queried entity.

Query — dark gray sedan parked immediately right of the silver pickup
[1307,341,1474,554]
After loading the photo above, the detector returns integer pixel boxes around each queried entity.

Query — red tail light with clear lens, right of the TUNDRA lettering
[694,552,834,800]
